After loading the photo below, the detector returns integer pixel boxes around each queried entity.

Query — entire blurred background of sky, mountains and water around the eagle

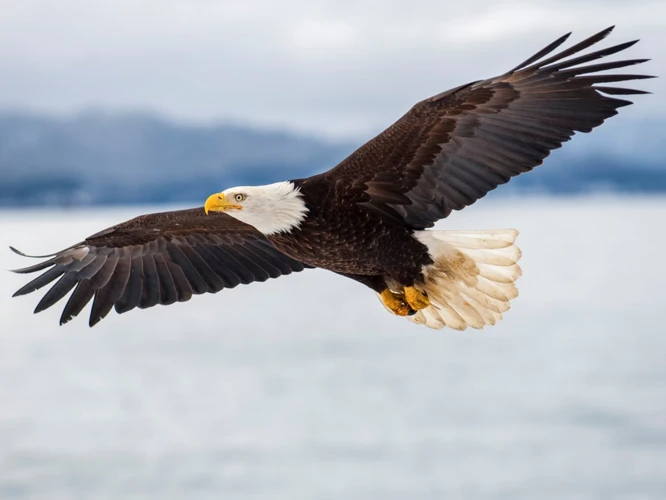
[0,0,666,500]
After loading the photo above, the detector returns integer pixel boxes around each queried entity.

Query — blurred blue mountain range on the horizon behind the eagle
[0,112,666,206]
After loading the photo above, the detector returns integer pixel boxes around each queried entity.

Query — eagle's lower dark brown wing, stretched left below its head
[12,208,310,326]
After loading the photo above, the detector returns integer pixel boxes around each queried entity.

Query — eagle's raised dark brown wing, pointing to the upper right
[323,27,651,229]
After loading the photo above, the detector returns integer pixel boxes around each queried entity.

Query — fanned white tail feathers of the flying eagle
[407,229,522,330]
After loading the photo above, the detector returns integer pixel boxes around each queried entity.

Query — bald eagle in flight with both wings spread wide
[13,27,650,330]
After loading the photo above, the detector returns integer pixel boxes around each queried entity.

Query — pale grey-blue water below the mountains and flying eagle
[0,198,666,500]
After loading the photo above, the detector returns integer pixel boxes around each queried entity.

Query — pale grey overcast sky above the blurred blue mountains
[0,0,666,138]
